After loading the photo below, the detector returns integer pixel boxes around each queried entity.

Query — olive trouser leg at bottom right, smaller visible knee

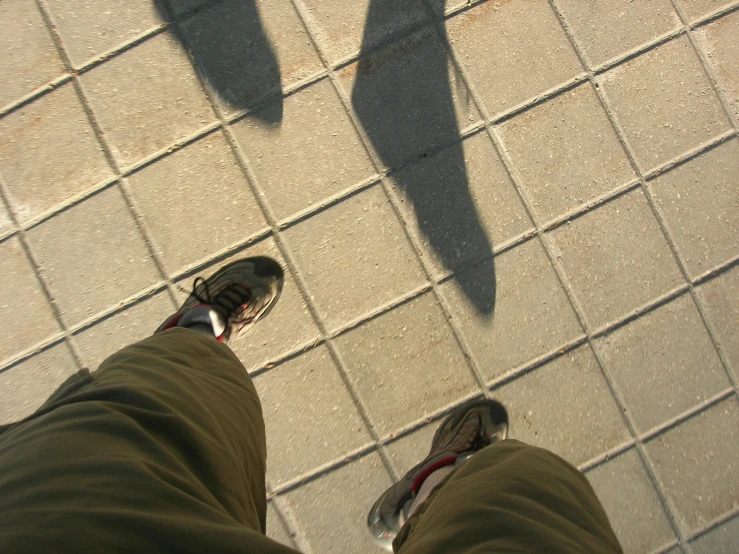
[394,440,621,554]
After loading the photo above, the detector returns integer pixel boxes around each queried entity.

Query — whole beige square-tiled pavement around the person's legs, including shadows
[0,0,739,553]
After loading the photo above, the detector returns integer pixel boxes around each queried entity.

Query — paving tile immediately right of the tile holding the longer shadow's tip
[547,190,683,328]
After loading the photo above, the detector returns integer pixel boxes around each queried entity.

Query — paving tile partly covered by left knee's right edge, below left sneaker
[254,346,371,486]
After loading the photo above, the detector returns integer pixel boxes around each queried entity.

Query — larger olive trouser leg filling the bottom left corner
[0,329,294,553]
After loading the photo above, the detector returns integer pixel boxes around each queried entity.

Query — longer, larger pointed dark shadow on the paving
[351,0,495,319]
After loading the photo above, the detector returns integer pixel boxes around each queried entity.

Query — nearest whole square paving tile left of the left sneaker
[27,188,160,328]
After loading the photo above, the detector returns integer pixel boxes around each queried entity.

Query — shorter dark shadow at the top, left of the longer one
[154,0,282,125]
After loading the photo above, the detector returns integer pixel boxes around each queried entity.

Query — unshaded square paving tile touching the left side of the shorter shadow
[81,33,215,166]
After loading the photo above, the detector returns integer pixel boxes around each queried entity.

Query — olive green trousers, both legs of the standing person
[0,329,620,554]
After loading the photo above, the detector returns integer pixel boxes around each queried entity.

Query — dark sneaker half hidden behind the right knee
[367,400,508,551]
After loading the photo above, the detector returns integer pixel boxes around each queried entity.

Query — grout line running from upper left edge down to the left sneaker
[36,0,178,324]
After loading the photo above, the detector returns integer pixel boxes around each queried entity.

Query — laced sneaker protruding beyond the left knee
[155,256,284,343]
